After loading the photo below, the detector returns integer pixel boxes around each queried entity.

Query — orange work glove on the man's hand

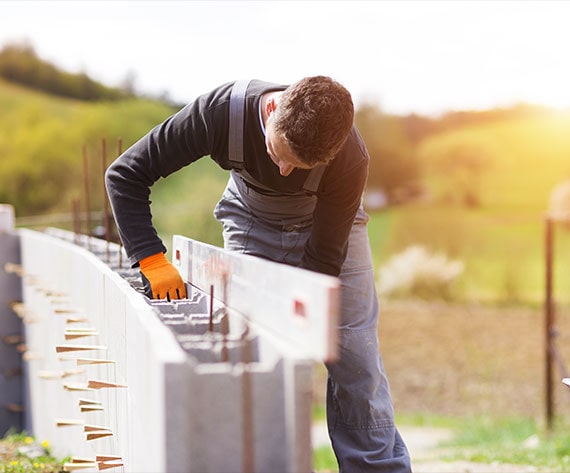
[139,253,186,301]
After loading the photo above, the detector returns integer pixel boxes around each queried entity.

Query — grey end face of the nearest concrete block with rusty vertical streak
[187,360,312,473]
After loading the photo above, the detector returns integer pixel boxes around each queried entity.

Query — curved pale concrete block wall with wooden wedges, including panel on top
[11,229,337,473]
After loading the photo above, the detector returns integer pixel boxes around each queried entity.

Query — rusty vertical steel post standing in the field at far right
[544,217,554,431]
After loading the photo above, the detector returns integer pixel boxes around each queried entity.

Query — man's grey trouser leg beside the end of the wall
[327,209,411,473]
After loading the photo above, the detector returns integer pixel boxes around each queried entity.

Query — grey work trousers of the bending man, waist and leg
[215,179,411,473]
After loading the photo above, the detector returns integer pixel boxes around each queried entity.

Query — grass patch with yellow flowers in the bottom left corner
[0,431,64,473]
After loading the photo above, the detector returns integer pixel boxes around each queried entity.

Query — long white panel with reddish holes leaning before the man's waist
[172,235,340,361]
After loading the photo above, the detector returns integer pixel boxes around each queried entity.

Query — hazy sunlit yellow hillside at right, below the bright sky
[412,111,570,211]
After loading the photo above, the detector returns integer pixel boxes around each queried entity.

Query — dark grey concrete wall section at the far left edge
[0,205,25,437]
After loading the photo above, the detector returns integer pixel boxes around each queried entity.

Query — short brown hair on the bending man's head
[274,76,354,166]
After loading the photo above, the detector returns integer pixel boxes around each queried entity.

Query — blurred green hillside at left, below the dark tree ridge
[0,80,178,216]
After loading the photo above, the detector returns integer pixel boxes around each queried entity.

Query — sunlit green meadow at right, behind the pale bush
[369,204,570,304]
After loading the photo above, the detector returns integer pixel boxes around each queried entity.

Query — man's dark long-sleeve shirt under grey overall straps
[106,80,369,276]
